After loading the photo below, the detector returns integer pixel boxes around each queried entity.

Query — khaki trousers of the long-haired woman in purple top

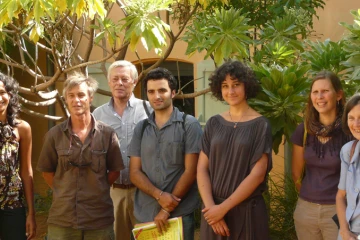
[294,198,339,240]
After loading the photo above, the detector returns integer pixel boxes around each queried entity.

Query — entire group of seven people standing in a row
[0,58,360,240]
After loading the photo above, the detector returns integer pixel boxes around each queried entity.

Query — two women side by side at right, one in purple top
[291,71,360,240]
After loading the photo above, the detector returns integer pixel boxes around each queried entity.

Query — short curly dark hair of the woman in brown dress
[209,61,260,101]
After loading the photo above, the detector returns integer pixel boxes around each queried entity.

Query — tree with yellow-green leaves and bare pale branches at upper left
[0,0,197,120]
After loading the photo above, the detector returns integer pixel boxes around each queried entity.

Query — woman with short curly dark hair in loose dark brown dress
[197,61,272,240]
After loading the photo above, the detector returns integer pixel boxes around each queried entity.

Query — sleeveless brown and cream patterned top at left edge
[0,123,24,209]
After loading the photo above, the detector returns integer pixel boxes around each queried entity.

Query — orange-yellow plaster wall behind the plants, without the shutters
[31,0,360,193]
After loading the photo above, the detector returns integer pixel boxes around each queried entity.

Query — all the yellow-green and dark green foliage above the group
[0,0,360,158]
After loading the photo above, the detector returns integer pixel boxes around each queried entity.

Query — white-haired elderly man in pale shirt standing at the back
[93,60,151,240]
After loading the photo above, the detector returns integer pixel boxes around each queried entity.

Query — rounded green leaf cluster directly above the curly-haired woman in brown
[183,8,251,64]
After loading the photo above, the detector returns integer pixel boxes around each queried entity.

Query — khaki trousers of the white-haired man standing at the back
[110,187,136,240]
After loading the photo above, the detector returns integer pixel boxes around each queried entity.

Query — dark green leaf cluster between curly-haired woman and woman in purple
[250,64,310,154]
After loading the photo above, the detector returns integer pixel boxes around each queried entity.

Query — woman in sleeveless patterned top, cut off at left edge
[0,73,36,240]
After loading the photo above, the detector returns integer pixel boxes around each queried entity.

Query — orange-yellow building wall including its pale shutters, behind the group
[32,0,360,193]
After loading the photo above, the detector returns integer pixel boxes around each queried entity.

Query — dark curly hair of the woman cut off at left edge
[0,72,20,127]
